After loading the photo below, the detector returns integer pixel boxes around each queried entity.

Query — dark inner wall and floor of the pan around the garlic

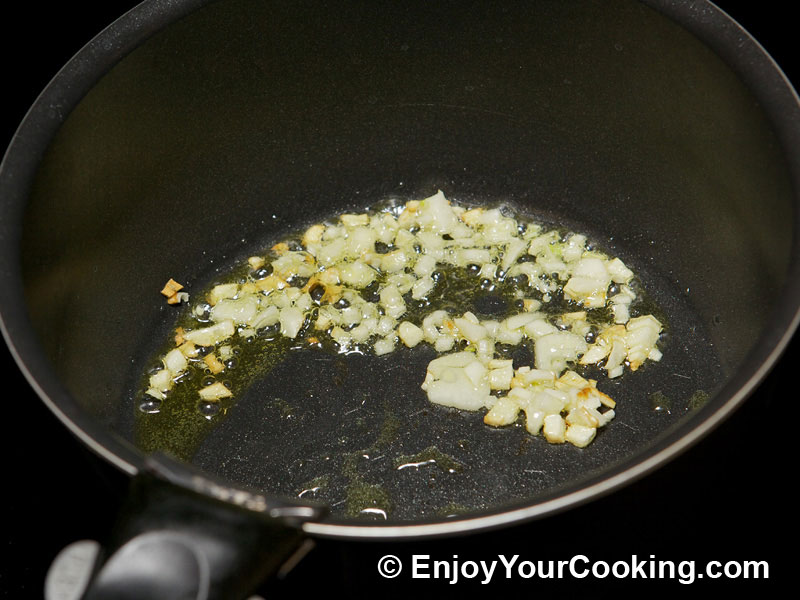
[15,0,794,520]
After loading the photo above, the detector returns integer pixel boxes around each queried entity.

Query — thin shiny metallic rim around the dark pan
[0,0,800,539]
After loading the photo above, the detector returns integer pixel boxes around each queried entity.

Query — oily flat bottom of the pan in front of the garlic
[130,199,722,522]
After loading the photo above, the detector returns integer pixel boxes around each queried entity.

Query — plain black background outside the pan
[0,1,800,598]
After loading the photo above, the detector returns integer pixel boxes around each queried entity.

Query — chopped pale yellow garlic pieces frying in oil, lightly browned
[145,191,663,447]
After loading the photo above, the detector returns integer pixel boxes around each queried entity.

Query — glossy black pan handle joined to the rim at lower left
[45,455,326,600]
